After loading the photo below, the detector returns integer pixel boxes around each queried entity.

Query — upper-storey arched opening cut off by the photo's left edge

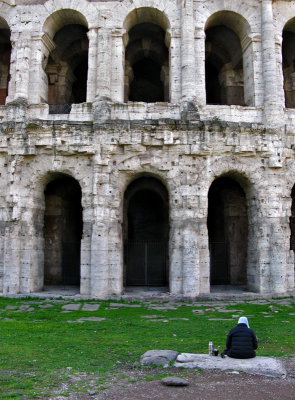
[0,18,11,105]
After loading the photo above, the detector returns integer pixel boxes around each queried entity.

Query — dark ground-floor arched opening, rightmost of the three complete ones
[207,177,248,286]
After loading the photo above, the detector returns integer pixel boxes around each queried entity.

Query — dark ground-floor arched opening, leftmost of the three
[44,175,83,286]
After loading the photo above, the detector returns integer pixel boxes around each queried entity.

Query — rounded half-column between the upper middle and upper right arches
[181,0,196,101]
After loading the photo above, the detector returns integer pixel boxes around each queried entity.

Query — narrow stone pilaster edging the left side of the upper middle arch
[111,28,125,102]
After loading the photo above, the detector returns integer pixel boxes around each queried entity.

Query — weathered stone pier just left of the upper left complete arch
[7,31,31,102]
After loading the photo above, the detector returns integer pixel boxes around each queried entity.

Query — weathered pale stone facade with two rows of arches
[0,0,295,297]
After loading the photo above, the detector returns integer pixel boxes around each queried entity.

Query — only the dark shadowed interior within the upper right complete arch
[205,25,245,105]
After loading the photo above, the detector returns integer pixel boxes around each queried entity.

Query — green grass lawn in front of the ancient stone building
[0,298,295,400]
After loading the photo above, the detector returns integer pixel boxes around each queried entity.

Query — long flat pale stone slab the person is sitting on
[174,353,286,378]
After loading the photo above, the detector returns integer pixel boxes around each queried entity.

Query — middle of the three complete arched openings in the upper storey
[124,8,169,103]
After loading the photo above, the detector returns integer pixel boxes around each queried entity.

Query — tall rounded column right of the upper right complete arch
[261,0,283,126]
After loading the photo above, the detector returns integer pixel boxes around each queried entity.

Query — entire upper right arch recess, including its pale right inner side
[205,10,255,106]
